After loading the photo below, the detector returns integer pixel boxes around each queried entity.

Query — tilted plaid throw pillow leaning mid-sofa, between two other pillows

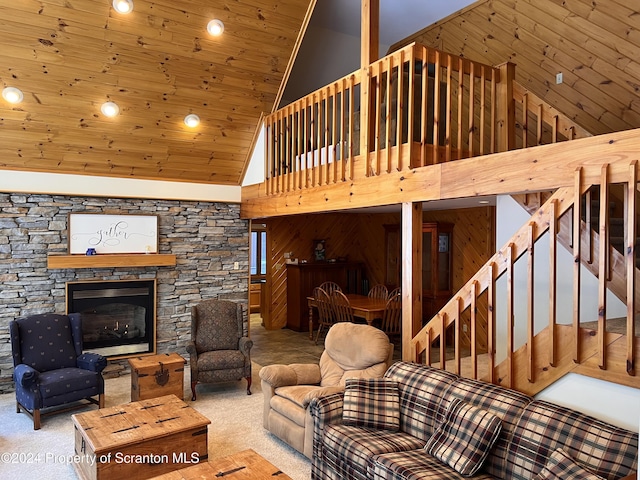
[424,398,502,476]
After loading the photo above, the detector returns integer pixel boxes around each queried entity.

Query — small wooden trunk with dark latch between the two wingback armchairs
[129,353,186,402]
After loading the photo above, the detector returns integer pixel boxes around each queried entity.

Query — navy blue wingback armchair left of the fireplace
[9,313,107,430]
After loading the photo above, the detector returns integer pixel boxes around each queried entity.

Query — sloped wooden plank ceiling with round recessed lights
[0,0,310,185]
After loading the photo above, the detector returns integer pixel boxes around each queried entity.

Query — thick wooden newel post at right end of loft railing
[494,62,516,152]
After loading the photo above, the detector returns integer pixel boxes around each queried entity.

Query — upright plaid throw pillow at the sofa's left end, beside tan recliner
[342,378,400,432]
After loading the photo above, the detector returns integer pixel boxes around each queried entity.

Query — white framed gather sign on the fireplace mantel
[68,213,158,255]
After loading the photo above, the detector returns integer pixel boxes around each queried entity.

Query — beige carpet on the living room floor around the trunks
[0,364,311,480]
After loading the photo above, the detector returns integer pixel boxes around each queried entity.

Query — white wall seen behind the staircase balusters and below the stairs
[496,196,640,431]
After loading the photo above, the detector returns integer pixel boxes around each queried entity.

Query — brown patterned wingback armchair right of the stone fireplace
[187,299,253,401]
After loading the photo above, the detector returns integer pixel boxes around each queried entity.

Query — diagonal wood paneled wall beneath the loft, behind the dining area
[262,207,495,329]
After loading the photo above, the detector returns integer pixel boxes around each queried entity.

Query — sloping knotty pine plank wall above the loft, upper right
[398,0,640,135]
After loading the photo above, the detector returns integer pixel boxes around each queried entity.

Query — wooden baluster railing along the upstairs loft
[265,44,502,195]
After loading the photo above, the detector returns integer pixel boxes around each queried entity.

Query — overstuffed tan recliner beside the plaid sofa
[259,322,393,458]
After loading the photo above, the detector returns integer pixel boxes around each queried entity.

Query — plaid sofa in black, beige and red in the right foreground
[310,362,638,480]
